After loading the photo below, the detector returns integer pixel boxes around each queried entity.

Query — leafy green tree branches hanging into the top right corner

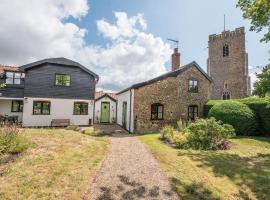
[237,0,270,42]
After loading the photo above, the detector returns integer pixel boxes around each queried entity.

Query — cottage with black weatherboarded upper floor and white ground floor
[0,58,99,127]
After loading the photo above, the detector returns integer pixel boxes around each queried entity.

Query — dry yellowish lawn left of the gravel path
[0,129,108,200]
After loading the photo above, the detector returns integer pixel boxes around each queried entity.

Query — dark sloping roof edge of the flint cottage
[117,61,212,94]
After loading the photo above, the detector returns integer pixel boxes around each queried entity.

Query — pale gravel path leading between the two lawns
[83,128,179,200]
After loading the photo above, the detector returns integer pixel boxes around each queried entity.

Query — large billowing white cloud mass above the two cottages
[0,0,171,90]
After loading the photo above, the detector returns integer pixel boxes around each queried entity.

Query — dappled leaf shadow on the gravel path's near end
[97,175,175,200]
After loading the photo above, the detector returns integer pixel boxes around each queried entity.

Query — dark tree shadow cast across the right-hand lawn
[178,152,270,200]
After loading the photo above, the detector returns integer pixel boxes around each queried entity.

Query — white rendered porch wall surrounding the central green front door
[95,97,116,123]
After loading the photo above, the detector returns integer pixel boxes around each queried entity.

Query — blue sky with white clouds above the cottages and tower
[0,0,270,91]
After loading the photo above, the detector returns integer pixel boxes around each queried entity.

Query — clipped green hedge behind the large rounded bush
[204,97,270,136]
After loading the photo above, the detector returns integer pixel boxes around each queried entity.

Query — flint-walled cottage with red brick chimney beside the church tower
[117,48,211,132]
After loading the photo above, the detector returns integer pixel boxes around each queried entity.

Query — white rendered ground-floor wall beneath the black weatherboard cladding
[23,97,94,127]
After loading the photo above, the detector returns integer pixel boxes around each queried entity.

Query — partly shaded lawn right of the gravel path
[139,134,270,200]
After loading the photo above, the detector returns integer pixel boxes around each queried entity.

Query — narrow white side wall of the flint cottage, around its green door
[117,89,134,132]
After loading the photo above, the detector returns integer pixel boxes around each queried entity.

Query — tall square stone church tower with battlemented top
[207,27,250,99]
